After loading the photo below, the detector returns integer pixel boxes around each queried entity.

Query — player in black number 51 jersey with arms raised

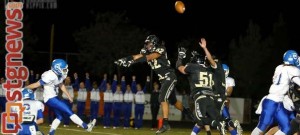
[176,38,225,135]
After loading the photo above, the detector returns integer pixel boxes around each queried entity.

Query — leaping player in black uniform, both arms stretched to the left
[115,35,192,134]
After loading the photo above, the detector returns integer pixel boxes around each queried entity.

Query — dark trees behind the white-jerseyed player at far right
[229,14,289,98]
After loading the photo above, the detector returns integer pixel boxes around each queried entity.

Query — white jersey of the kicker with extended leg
[41,70,67,103]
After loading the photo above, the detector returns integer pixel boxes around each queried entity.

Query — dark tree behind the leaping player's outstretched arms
[74,12,148,74]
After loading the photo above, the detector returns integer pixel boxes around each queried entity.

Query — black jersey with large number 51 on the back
[185,63,214,94]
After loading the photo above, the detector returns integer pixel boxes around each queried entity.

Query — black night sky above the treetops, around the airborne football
[25,0,300,56]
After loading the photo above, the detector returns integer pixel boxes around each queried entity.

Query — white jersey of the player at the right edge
[267,65,300,102]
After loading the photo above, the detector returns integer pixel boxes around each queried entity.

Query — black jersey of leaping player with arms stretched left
[141,46,174,78]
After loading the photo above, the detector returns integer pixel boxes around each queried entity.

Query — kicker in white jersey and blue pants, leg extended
[26,59,96,135]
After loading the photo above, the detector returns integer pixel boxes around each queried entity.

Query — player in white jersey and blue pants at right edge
[251,50,300,135]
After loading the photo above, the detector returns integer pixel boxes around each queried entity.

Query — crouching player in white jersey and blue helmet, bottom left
[18,89,44,135]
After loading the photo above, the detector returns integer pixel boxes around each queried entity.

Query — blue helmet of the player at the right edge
[283,50,299,66]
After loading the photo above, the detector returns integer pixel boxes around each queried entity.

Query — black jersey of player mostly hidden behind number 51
[213,61,226,96]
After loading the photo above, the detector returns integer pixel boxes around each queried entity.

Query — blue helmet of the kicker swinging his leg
[51,59,69,76]
